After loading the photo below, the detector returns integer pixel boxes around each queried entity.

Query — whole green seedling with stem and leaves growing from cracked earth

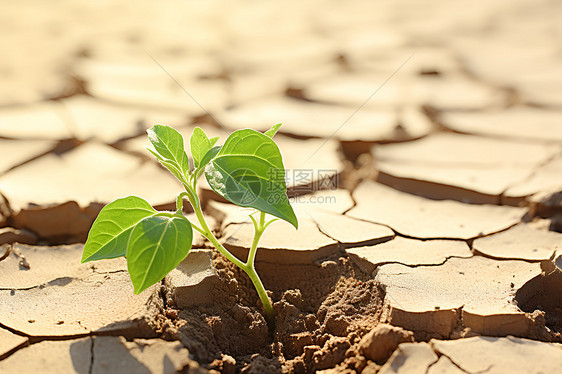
[82,124,298,326]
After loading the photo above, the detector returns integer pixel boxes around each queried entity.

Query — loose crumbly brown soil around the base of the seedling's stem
[160,255,384,373]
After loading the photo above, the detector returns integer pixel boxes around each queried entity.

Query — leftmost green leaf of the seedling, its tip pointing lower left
[82,196,157,263]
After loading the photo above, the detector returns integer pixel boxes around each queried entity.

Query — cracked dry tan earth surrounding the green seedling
[0,0,562,374]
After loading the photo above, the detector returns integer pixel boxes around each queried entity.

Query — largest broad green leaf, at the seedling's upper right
[205,129,298,228]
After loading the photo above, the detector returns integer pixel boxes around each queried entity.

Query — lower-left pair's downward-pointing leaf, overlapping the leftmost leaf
[127,213,193,294]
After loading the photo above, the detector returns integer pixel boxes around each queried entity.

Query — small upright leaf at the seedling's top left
[147,125,189,181]
